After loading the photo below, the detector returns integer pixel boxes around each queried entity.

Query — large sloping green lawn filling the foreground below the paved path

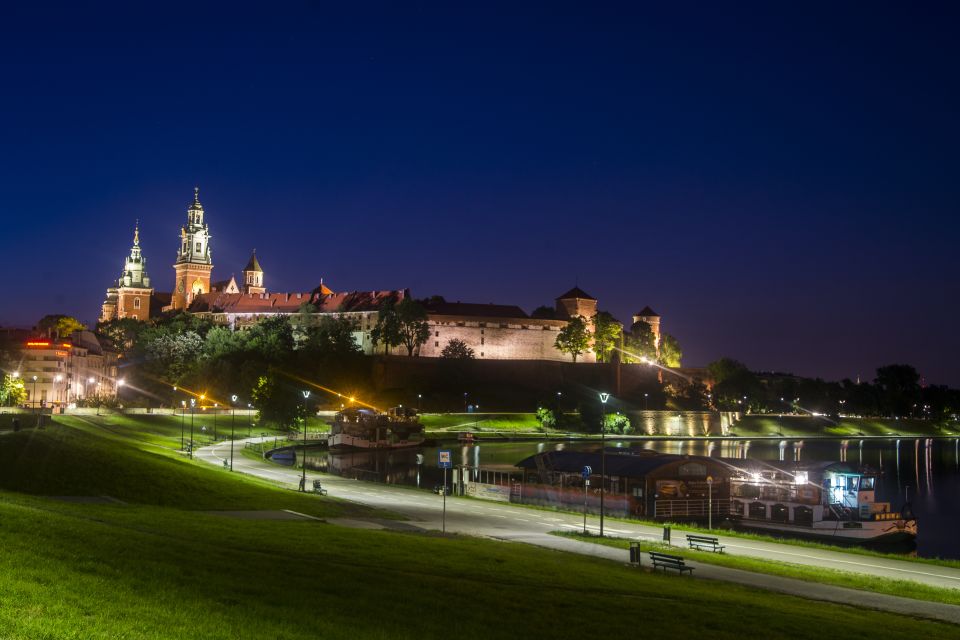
[0,418,956,640]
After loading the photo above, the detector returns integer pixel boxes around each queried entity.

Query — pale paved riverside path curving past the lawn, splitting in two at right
[196,438,960,624]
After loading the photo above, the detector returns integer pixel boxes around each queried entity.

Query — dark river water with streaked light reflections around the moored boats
[296,438,960,558]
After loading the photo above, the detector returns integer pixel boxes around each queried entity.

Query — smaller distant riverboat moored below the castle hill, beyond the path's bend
[327,407,423,451]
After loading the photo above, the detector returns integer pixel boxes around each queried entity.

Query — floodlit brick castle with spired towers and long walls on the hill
[100,189,660,362]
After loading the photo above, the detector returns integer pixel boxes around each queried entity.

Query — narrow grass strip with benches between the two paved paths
[554,531,960,605]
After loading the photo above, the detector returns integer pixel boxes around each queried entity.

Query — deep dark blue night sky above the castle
[0,2,960,385]
